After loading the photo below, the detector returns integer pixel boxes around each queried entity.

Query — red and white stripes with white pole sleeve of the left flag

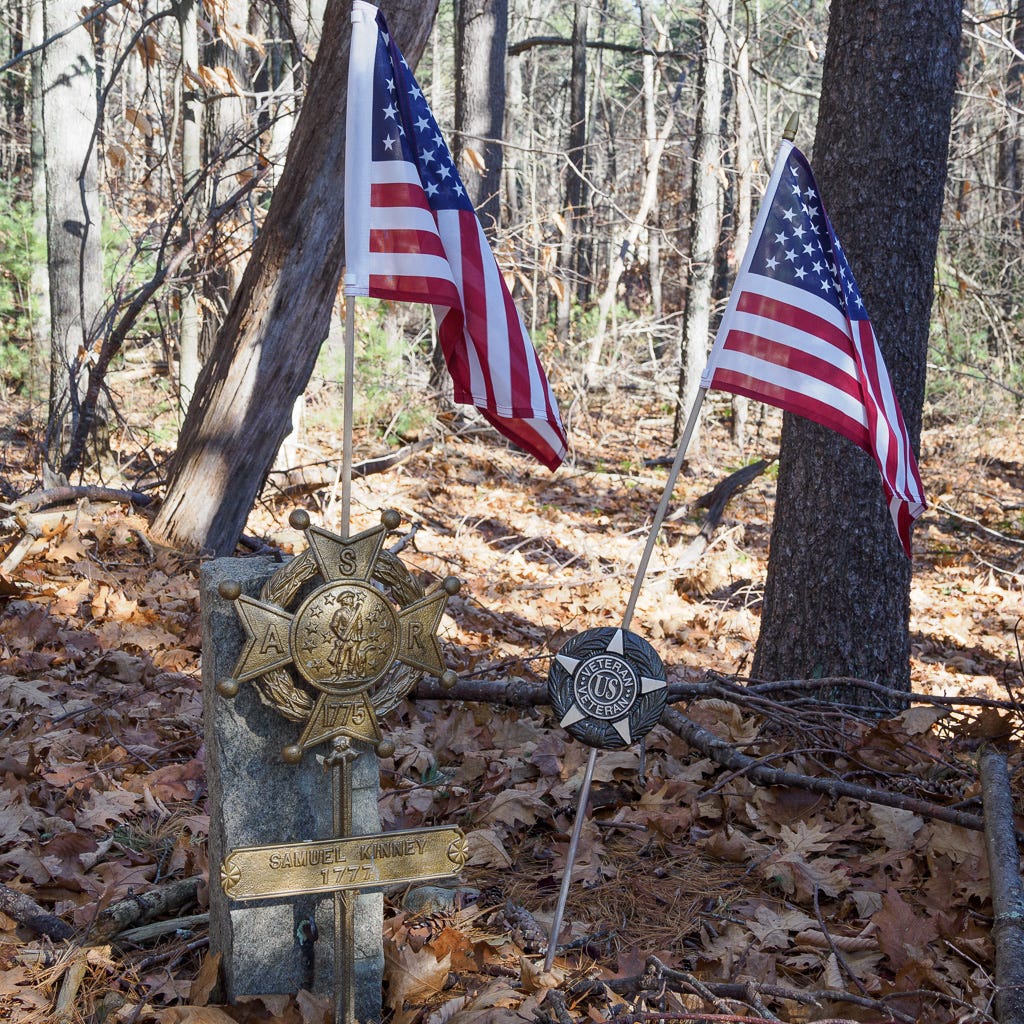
[345,0,566,469]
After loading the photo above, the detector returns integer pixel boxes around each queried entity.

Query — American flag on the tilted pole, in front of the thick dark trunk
[700,142,926,558]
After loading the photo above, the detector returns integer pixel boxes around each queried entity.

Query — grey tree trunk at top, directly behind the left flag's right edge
[455,0,509,233]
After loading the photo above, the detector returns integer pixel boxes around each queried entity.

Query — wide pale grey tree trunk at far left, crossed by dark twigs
[41,0,102,465]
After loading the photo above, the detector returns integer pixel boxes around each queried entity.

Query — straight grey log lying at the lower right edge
[981,745,1024,1024]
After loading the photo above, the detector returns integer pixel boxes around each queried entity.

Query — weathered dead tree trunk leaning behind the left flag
[153,0,436,555]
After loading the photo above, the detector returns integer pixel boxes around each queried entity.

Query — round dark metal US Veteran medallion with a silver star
[548,627,668,750]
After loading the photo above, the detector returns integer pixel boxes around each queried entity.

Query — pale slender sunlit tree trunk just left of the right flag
[673,0,729,446]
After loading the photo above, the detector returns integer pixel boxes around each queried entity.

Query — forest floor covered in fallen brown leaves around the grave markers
[0,391,1024,1024]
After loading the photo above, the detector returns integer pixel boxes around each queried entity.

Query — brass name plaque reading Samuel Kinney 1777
[220,825,469,900]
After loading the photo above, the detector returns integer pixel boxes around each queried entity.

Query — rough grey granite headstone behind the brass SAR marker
[201,557,384,1022]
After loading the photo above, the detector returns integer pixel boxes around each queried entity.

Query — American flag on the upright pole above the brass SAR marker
[345,0,565,469]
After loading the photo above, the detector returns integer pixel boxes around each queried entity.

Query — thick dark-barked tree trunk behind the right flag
[753,0,961,689]
